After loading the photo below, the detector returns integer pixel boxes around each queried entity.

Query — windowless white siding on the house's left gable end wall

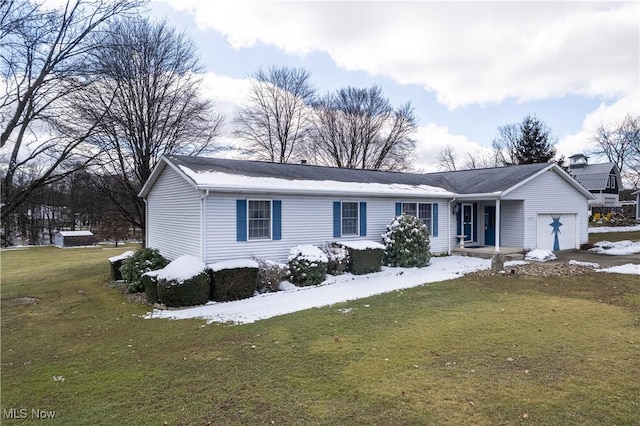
[146,166,201,260]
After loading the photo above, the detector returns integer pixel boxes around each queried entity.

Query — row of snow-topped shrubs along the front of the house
[120,215,431,306]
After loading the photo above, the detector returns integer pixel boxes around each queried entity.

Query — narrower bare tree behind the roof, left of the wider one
[234,67,315,163]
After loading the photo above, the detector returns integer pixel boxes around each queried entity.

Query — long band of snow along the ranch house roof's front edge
[179,165,453,197]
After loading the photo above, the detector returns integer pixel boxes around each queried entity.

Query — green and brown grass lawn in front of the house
[1,247,640,425]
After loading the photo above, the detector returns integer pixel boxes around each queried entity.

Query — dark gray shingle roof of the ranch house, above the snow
[167,155,549,194]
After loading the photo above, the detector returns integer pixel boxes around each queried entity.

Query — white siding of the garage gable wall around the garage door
[503,170,589,250]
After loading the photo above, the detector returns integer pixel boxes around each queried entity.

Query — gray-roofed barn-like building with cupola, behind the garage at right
[569,154,622,208]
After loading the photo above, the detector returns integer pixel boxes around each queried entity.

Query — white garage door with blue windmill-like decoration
[537,213,578,251]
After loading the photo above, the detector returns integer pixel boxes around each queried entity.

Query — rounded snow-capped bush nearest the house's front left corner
[156,255,211,307]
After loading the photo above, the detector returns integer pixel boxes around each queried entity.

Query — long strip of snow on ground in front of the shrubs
[145,256,484,324]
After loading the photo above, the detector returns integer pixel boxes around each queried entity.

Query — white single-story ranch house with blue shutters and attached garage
[140,156,594,263]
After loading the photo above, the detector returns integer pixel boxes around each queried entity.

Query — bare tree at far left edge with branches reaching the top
[0,0,141,246]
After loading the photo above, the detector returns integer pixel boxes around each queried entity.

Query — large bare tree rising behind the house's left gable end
[75,19,223,238]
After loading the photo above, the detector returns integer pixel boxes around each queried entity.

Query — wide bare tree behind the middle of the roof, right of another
[310,86,416,171]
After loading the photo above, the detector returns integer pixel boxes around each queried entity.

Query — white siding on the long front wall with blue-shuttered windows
[206,194,447,263]
